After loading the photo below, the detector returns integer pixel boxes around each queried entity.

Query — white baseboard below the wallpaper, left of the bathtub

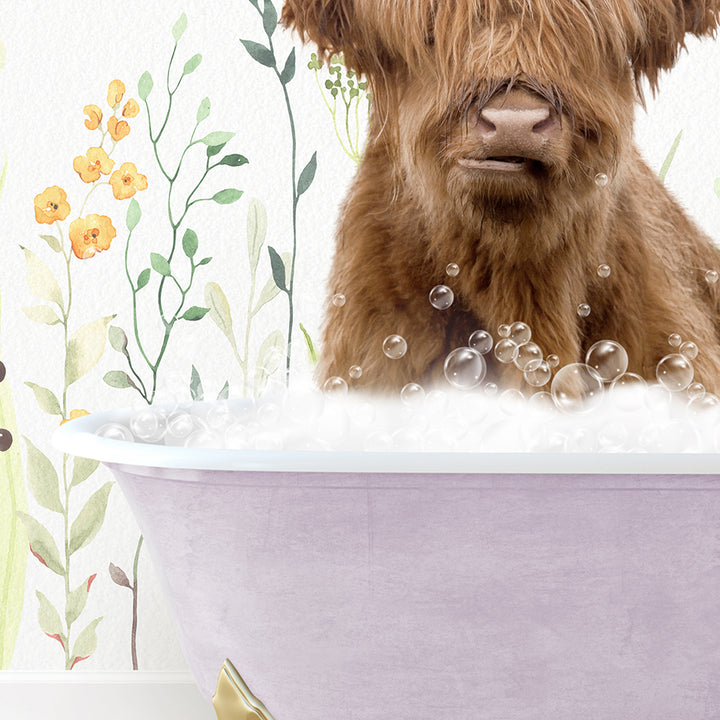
[0,671,217,720]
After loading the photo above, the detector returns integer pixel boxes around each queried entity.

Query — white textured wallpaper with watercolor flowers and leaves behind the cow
[0,0,720,671]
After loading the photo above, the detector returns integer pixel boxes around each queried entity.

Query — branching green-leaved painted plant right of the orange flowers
[104,13,248,404]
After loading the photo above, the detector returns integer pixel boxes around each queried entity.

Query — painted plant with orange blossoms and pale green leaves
[17,80,152,670]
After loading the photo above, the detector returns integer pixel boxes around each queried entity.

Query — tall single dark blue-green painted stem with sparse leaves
[240,0,317,385]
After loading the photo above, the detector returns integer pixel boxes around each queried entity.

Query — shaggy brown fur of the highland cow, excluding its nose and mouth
[282,0,720,392]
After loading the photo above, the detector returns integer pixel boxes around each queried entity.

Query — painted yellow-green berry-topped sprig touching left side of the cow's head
[308,53,371,165]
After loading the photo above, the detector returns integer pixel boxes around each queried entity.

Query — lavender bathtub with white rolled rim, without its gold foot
[55,411,720,720]
